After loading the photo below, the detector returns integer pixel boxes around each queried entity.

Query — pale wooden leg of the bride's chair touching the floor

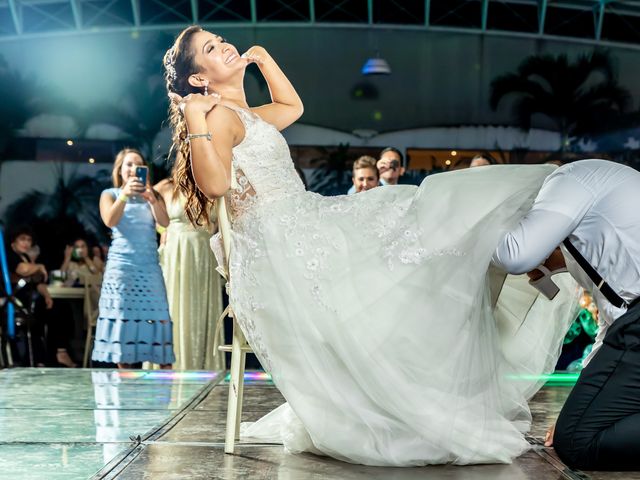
[224,319,246,453]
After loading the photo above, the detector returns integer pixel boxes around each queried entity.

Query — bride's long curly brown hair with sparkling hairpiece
[163,25,213,226]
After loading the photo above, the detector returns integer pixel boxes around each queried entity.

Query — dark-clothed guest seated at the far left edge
[7,227,76,367]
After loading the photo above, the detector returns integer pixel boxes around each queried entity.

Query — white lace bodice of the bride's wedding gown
[227,107,305,220]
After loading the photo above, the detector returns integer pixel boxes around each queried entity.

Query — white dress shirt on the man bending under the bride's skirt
[493,160,640,365]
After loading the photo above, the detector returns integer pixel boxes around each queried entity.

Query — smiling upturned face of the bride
[191,31,247,90]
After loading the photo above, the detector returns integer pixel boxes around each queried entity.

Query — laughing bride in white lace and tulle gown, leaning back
[164,26,572,466]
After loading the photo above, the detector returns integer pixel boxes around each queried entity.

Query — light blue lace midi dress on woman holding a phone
[92,188,175,364]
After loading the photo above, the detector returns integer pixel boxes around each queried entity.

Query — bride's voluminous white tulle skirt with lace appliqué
[216,166,577,466]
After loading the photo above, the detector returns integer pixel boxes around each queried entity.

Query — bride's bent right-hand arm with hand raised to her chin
[244,46,304,130]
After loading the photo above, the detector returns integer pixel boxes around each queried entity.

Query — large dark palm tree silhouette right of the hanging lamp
[490,51,631,149]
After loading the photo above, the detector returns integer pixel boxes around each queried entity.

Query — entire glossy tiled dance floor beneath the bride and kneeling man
[0,369,640,480]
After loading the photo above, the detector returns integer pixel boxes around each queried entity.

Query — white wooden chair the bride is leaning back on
[216,192,252,453]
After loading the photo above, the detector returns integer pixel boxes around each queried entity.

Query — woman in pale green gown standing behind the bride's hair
[155,179,224,370]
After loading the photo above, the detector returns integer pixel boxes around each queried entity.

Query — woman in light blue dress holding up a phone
[92,148,175,368]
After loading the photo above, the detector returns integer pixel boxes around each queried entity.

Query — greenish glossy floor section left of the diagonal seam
[0,368,222,480]
